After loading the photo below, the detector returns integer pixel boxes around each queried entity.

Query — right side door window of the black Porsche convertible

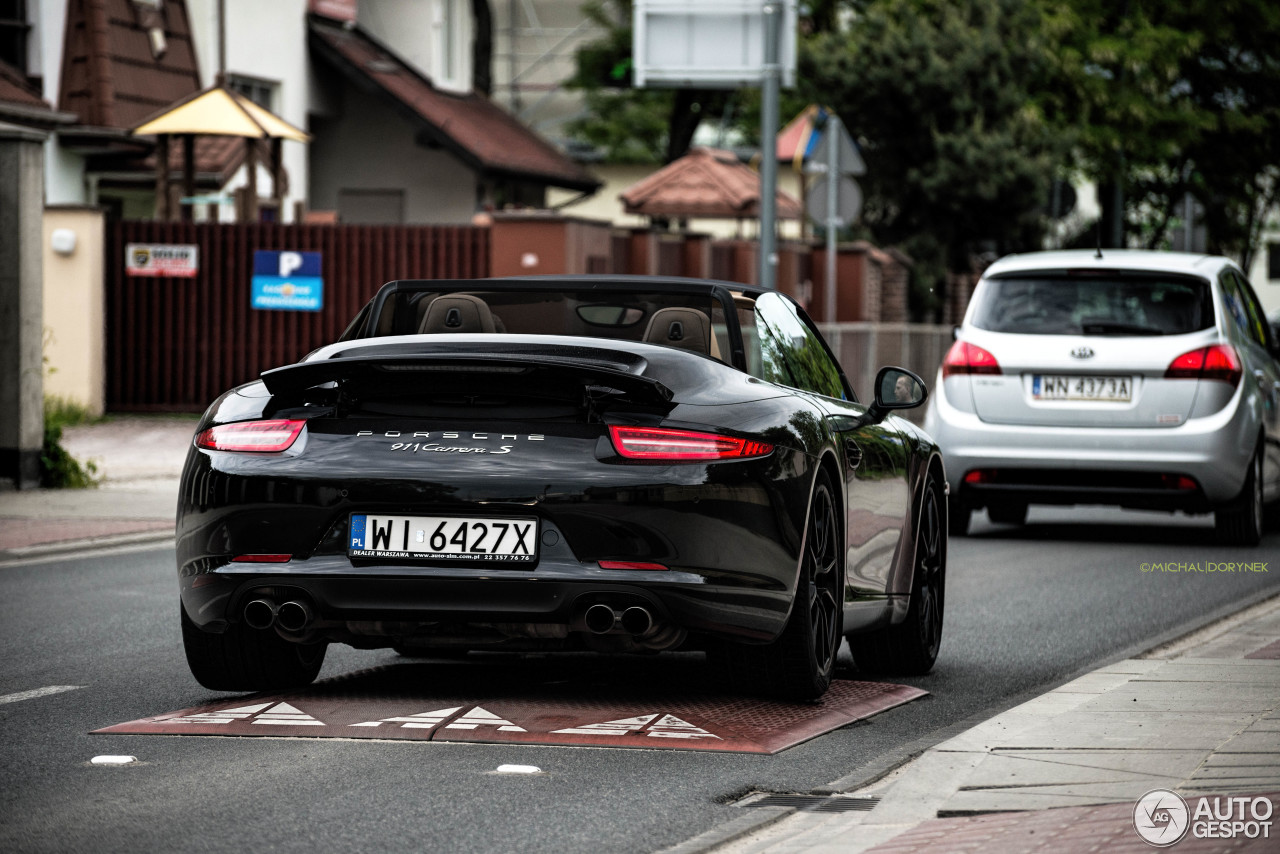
[754,293,844,399]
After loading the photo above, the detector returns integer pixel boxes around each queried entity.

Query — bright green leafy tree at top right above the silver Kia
[1046,0,1280,269]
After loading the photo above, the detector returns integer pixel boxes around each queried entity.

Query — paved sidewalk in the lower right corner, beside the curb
[703,597,1280,854]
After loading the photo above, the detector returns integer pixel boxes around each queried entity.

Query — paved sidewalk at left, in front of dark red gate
[0,416,196,563]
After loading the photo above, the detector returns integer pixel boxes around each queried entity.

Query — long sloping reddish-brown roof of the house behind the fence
[308,15,600,192]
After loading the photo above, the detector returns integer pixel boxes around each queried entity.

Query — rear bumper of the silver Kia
[925,383,1258,512]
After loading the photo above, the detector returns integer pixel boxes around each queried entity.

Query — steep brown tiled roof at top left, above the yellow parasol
[58,0,200,128]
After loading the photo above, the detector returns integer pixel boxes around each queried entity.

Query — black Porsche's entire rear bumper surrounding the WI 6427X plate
[177,449,810,645]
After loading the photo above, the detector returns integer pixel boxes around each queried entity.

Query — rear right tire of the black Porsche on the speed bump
[708,472,844,700]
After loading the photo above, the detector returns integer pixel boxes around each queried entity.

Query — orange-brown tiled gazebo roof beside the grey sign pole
[618,149,801,219]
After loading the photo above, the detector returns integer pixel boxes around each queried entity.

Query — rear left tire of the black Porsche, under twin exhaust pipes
[179,606,328,691]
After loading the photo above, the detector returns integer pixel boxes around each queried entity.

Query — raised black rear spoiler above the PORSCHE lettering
[261,352,675,405]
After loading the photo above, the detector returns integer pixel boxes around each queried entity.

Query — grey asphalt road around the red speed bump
[0,508,1280,854]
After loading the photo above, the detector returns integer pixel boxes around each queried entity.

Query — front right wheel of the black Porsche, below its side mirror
[849,475,947,676]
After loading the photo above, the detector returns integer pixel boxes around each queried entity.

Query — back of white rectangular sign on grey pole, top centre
[631,0,797,88]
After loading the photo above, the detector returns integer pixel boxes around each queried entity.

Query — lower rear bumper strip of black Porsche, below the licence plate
[180,558,791,645]
